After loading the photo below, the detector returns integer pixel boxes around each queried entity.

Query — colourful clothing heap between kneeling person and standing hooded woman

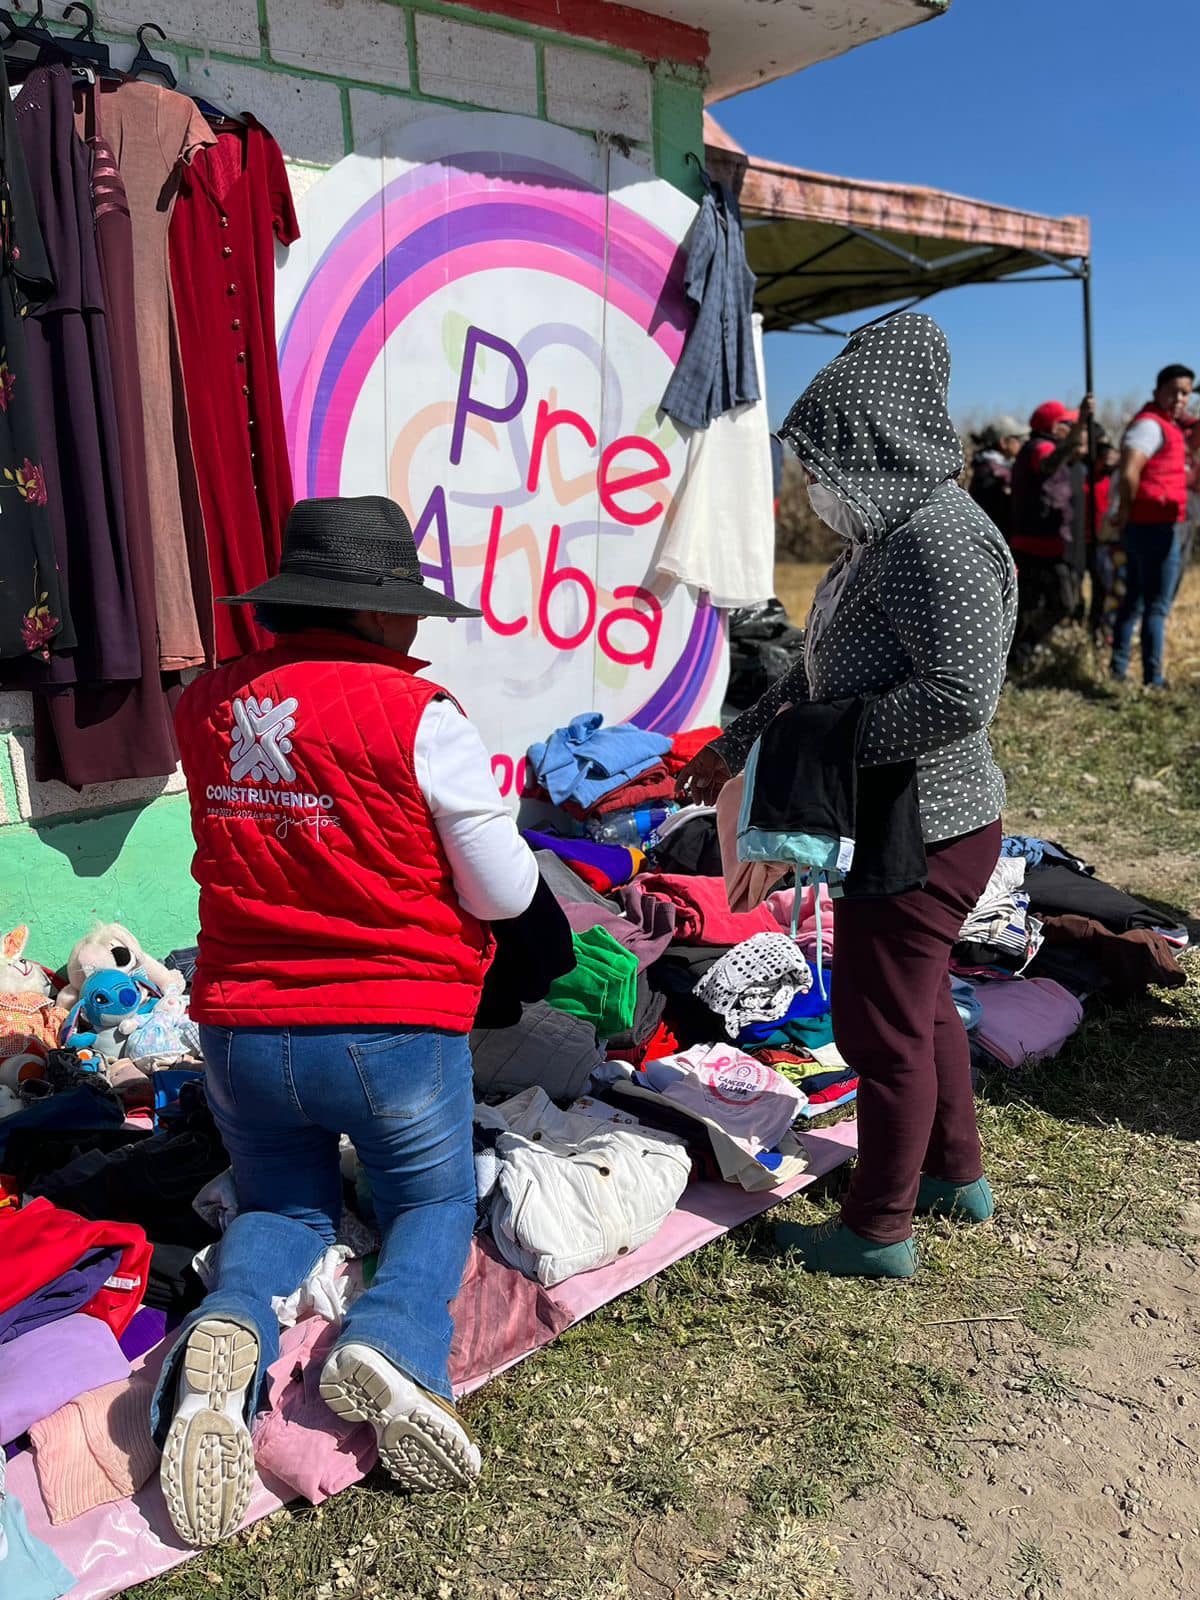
[457,714,858,1285]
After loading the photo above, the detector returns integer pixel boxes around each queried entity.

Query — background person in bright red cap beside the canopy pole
[1005,395,1093,664]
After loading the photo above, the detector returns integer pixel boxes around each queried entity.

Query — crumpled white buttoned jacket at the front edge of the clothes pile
[475,1086,691,1288]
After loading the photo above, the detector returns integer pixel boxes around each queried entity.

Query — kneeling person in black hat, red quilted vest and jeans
[154,498,538,1544]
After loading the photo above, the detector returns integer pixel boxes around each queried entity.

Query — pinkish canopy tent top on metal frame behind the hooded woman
[704,115,1091,363]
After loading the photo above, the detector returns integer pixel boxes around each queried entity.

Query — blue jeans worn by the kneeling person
[150,1027,475,1442]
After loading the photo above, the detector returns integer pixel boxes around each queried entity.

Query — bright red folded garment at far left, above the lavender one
[0,1198,152,1336]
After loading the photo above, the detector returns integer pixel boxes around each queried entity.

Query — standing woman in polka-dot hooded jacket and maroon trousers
[680,314,1016,1277]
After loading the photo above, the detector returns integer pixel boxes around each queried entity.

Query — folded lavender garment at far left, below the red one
[0,1314,130,1445]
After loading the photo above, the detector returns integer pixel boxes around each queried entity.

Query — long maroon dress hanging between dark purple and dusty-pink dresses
[34,78,178,787]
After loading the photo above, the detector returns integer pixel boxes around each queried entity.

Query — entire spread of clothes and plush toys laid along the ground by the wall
[0,793,1186,1595]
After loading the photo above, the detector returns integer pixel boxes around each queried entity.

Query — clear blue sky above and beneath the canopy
[712,0,1200,422]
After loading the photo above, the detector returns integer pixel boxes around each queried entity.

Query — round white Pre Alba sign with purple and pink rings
[280,114,726,794]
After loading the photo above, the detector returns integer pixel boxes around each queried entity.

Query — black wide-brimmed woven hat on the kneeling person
[221,494,483,616]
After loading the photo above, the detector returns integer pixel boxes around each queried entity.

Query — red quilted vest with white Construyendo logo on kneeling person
[176,632,491,1034]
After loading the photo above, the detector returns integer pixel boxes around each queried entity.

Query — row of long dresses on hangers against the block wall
[0,15,298,789]
